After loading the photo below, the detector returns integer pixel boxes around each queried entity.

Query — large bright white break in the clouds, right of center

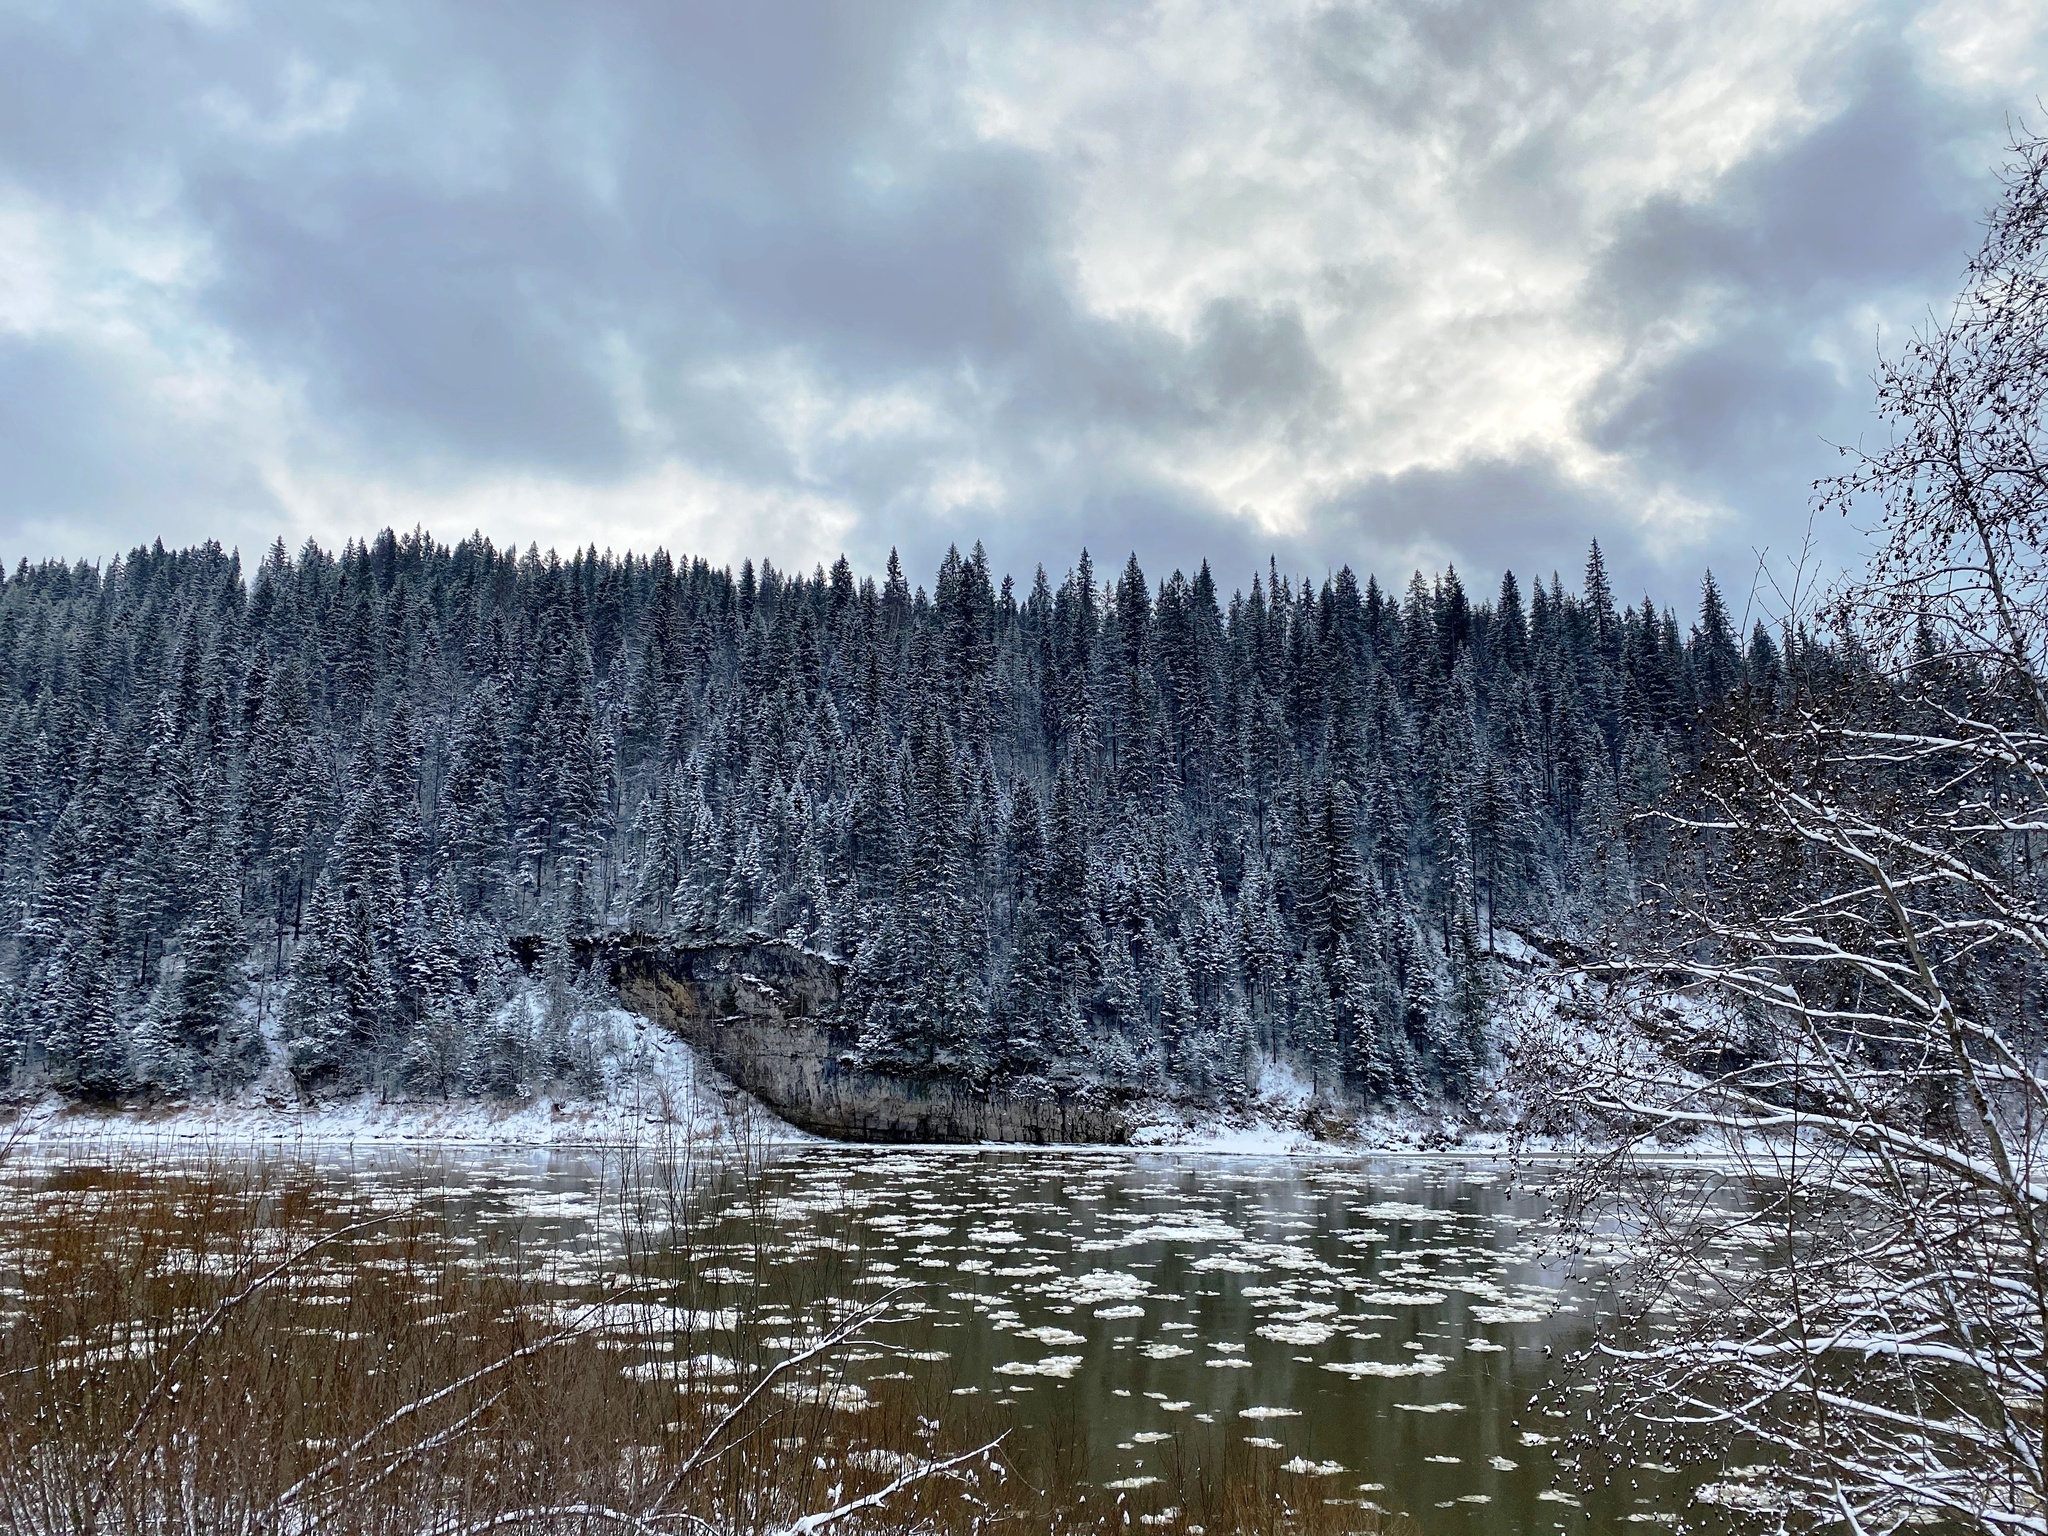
[937,4,1875,559]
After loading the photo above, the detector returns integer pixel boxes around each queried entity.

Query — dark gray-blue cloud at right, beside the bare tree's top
[1585,45,1995,581]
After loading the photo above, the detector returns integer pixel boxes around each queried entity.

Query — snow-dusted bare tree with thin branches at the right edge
[1546,133,2048,1532]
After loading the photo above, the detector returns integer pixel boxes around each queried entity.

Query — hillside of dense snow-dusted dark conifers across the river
[0,532,1780,1100]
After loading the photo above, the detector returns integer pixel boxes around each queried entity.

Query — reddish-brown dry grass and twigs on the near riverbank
[0,1122,1409,1536]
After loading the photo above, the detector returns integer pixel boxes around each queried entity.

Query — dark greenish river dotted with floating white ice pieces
[14,1145,1712,1536]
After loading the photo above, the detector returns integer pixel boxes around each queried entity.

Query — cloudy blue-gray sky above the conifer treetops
[0,0,2048,606]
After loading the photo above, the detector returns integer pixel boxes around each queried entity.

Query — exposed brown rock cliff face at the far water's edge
[592,938,1128,1145]
